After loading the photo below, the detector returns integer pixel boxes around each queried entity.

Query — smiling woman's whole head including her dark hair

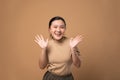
[49,16,66,40]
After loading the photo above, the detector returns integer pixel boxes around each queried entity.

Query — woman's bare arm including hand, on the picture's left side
[35,35,48,69]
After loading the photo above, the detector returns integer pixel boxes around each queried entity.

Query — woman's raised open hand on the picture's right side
[70,35,83,48]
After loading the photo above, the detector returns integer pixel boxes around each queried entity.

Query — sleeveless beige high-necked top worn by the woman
[47,38,79,75]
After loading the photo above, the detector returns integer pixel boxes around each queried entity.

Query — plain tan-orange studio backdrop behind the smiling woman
[0,0,120,80]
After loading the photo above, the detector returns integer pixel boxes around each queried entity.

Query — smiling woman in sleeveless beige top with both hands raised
[35,16,82,80]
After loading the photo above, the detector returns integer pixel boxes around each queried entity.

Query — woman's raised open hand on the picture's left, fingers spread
[34,35,48,49]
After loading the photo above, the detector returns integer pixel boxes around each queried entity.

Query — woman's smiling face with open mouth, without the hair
[49,20,66,40]
